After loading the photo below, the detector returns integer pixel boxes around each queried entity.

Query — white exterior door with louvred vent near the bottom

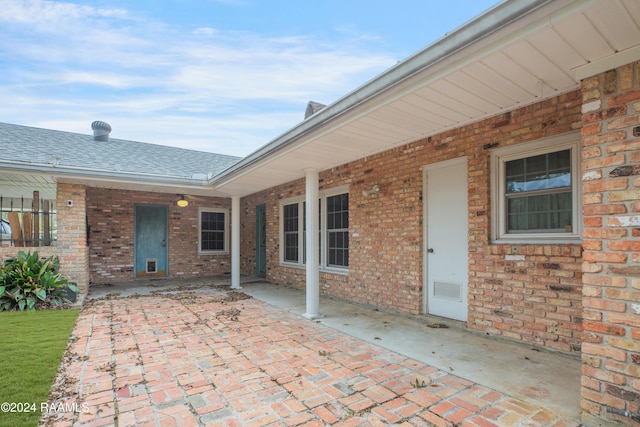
[423,157,469,321]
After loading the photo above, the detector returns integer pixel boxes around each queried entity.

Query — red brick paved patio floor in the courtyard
[42,288,579,427]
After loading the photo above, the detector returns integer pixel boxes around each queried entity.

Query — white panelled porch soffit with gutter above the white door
[214,0,640,196]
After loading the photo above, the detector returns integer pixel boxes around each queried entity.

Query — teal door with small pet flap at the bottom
[134,205,168,277]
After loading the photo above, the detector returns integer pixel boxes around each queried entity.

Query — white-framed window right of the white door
[491,134,580,243]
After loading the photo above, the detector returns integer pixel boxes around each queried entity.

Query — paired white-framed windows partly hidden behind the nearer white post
[280,188,349,272]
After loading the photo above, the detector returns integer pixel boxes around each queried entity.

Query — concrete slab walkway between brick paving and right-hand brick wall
[242,281,582,419]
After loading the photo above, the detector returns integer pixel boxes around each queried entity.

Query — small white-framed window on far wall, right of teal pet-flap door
[198,208,229,254]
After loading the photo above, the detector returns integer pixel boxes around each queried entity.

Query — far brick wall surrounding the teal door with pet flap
[87,188,231,283]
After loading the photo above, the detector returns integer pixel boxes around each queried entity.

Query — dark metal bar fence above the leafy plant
[0,191,58,247]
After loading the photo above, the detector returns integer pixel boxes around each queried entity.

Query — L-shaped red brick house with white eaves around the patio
[0,0,640,426]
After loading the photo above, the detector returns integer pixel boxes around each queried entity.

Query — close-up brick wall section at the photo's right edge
[582,63,640,425]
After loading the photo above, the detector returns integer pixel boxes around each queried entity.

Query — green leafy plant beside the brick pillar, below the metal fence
[0,251,79,311]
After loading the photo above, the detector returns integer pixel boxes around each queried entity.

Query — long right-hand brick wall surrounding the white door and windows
[241,91,582,352]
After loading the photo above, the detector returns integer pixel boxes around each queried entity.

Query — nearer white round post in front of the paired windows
[303,169,322,319]
